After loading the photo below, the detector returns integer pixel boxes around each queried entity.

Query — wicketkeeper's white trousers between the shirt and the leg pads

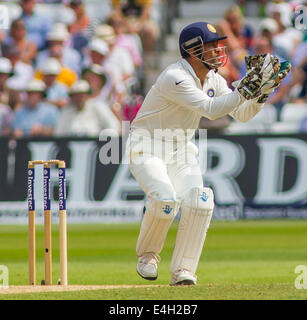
[129,141,203,201]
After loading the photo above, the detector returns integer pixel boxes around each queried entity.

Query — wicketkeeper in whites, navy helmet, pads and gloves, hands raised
[127,22,291,285]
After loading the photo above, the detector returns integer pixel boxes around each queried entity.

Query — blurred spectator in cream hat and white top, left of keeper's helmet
[96,24,135,81]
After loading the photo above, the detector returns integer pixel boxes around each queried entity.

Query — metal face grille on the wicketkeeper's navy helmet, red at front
[181,36,228,71]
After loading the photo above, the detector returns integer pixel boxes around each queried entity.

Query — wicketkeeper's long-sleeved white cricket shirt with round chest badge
[131,59,262,139]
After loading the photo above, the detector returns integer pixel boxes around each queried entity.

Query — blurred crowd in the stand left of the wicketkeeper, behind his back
[0,0,159,138]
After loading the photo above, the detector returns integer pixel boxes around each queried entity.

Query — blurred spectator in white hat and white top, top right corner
[268,3,303,61]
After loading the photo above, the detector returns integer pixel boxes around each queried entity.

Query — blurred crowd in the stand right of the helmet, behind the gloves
[202,0,307,131]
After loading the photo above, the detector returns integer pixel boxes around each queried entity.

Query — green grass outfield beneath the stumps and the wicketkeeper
[0,220,307,300]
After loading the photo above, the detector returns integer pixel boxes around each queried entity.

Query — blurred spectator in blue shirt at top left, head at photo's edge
[19,0,52,50]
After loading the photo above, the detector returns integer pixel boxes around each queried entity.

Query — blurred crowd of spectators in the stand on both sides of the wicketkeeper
[0,0,307,138]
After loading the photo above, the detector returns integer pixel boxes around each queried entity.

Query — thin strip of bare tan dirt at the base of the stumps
[0,285,168,295]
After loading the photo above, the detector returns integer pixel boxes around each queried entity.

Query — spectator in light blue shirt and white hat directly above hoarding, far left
[12,79,59,138]
